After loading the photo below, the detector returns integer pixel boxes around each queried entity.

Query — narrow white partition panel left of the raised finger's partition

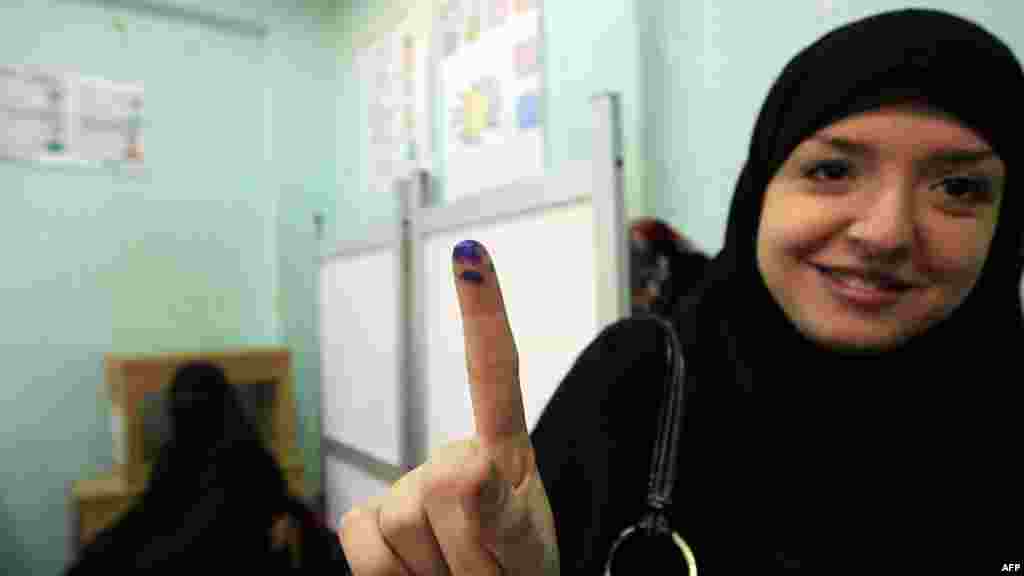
[319,196,409,466]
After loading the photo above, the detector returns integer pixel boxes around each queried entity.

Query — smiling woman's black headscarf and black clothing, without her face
[532,10,1024,575]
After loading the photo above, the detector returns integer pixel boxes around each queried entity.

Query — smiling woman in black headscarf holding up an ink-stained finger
[342,9,1024,574]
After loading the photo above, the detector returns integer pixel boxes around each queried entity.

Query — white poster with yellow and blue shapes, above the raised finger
[438,0,544,201]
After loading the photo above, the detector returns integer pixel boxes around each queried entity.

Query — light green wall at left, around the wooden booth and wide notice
[0,0,337,574]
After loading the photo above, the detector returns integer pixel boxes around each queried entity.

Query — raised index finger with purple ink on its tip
[452,240,528,447]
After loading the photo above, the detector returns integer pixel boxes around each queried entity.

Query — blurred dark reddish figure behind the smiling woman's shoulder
[630,218,709,316]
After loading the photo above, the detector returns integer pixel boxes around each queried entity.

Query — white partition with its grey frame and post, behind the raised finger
[411,95,628,459]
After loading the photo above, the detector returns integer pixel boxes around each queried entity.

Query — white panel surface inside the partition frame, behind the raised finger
[423,194,598,440]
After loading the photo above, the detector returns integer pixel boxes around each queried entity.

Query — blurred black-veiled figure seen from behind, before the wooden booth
[70,362,296,574]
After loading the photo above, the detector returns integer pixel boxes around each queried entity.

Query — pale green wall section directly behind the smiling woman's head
[638,0,1024,253]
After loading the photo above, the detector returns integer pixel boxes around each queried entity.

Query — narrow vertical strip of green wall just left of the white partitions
[266,0,339,524]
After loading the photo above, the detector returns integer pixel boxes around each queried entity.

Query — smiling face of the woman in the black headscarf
[757,106,1006,352]
